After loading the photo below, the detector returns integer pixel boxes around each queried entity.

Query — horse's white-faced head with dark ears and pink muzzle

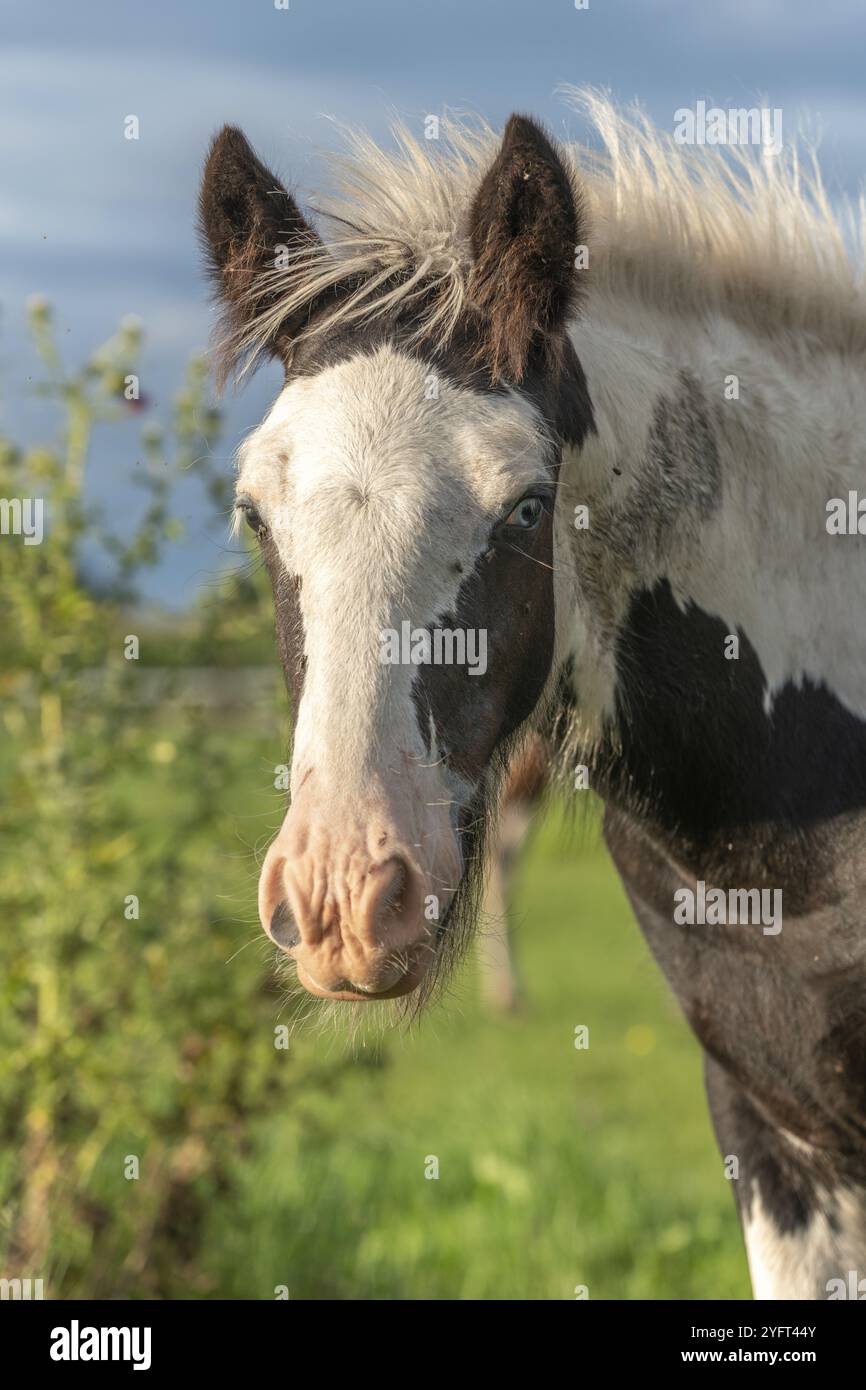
[200,108,591,999]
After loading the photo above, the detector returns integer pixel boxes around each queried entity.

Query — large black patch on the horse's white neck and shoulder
[599,580,866,849]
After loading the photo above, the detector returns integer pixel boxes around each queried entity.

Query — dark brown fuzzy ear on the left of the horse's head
[199,125,321,375]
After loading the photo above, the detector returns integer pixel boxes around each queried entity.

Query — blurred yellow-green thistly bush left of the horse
[0,302,319,1298]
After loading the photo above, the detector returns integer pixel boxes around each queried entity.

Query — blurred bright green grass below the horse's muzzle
[200,813,749,1300]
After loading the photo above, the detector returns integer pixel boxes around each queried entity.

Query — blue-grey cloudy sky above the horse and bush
[0,0,866,609]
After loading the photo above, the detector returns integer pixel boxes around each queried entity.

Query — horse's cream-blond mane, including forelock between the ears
[224,88,866,378]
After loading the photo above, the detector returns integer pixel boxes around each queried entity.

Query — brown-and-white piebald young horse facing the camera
[200,92,866,1298]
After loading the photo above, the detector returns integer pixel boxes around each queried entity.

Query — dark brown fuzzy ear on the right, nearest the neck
[470,115,584,382]
